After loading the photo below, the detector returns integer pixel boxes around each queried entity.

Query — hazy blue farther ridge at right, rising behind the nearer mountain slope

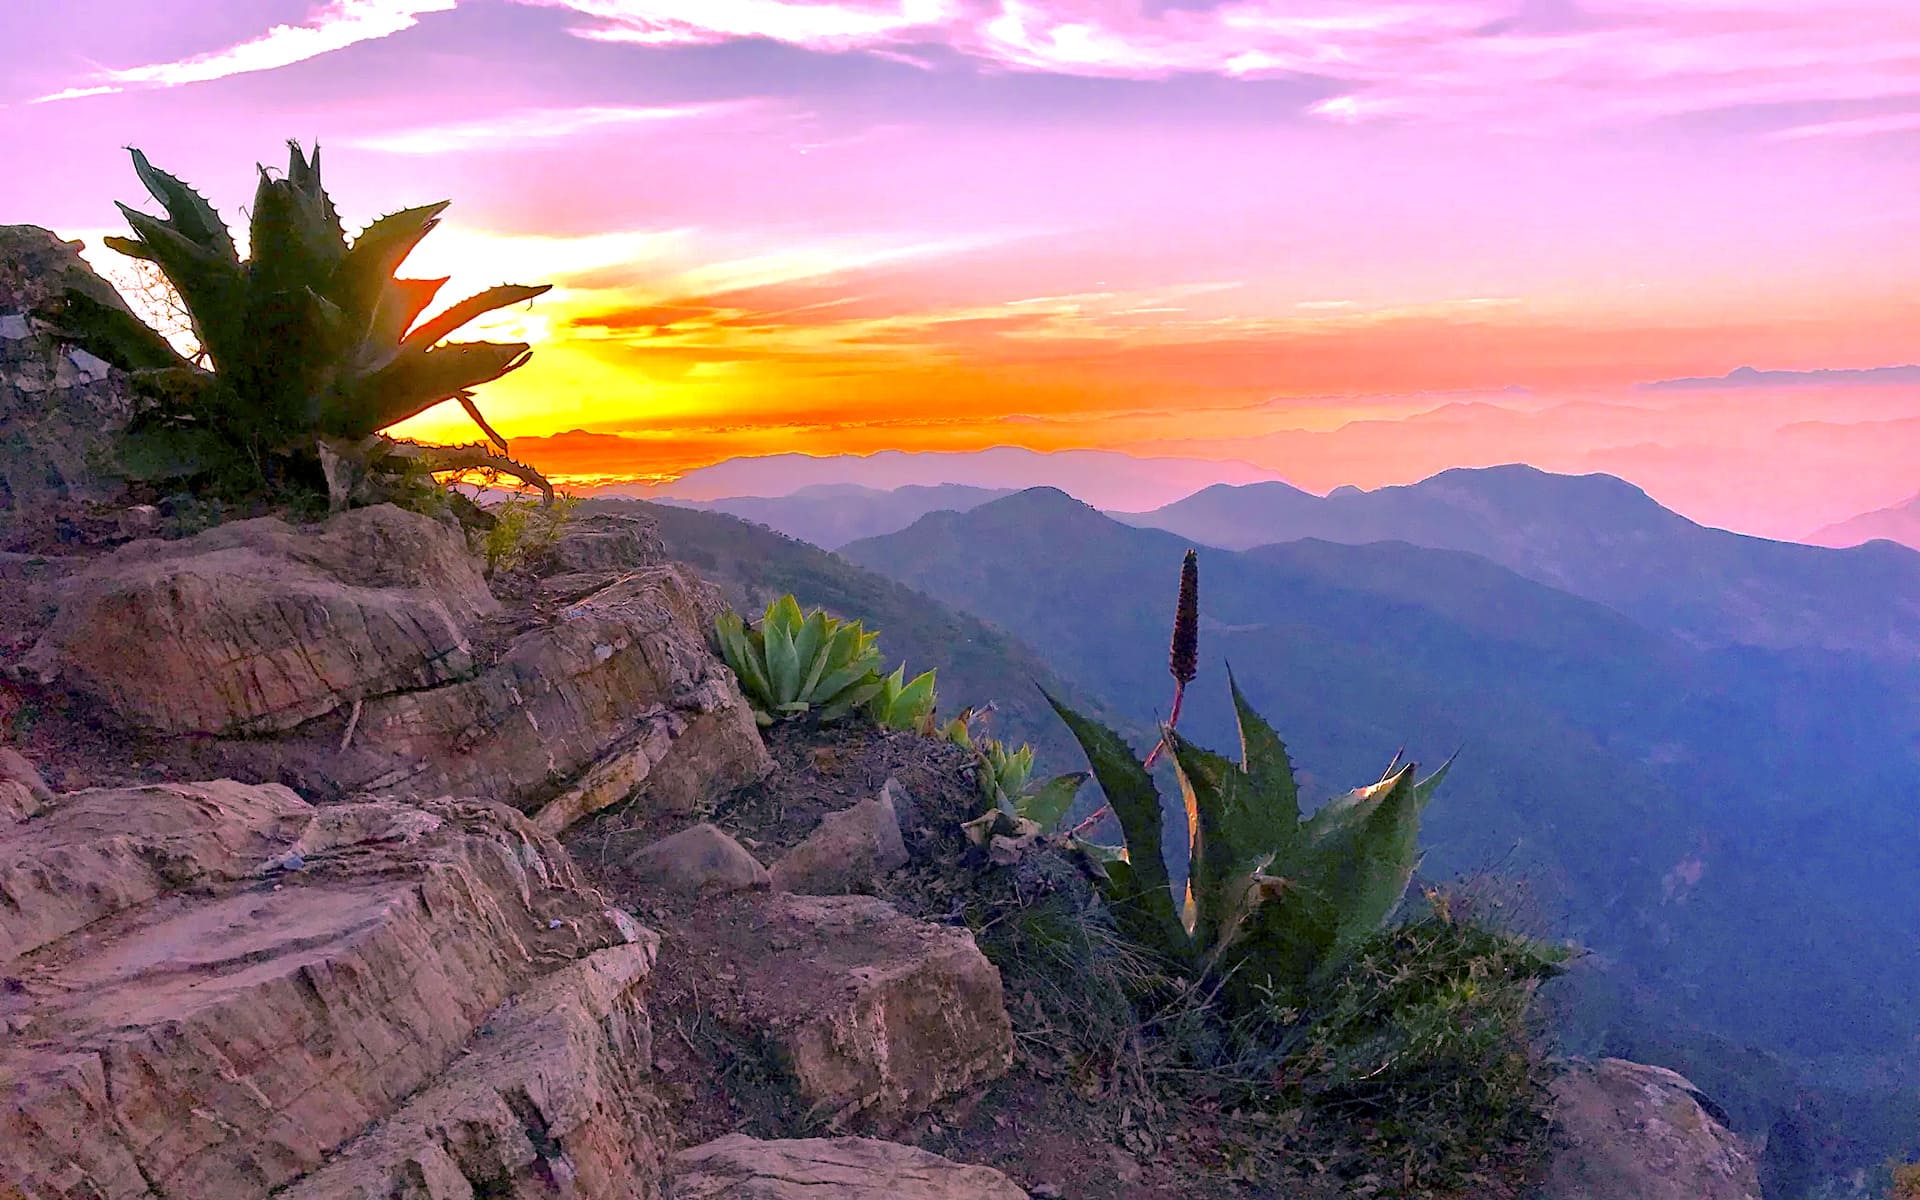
[1117,465,1920,657]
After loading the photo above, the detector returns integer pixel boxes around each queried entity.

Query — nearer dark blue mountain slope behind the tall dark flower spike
[843,490,1920,1182]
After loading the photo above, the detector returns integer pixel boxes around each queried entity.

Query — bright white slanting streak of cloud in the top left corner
[40,0,459,102]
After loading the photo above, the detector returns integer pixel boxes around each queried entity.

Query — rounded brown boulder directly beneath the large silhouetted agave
[15,505,495,735]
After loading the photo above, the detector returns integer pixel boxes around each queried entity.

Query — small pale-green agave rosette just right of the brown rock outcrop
[714,593,883,726]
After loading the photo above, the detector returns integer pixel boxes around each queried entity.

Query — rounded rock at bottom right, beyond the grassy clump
[1540,1058,1761,1200]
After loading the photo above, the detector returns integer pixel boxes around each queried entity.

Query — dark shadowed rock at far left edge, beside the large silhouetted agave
[0,225,132,534]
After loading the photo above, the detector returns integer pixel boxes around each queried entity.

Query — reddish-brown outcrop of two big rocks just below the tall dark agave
[10,505,772,833]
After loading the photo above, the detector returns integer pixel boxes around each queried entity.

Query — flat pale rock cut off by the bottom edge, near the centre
[666,1133,1027,1200]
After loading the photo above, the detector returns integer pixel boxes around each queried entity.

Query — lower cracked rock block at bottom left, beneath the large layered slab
[278,937,672,1200]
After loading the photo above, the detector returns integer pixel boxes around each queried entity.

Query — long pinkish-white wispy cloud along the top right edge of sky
[518,0,1920,136]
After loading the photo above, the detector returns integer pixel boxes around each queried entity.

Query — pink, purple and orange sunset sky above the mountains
[0,0,1920,536]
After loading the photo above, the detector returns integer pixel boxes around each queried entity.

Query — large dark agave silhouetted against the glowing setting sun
[50,142,553,507]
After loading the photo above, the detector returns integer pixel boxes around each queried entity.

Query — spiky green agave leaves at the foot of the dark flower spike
[1048,672,1446,998]
